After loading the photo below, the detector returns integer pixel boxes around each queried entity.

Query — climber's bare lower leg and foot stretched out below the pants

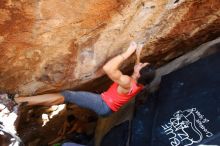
[15,93,64,106]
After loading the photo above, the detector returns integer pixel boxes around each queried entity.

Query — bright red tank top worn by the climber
[101,80,143,112]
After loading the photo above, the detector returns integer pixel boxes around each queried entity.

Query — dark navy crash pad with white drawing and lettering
[131,53,220,146]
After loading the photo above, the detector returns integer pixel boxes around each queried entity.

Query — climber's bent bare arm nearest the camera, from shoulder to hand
[103,42,137,89]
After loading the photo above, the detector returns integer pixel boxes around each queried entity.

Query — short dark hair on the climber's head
[137,64,156,86]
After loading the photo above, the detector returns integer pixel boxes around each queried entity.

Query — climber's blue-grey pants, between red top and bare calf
[61,91,112,116]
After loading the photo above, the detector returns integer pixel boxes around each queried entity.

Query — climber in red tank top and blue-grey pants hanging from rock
[15,42,155,116]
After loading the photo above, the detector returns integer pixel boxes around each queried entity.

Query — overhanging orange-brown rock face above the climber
[0,0,220,95]
